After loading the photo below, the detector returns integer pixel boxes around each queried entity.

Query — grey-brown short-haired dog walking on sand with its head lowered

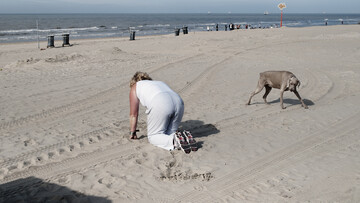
[247,71,308,109]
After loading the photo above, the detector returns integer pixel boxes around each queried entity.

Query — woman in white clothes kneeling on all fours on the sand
[129,72,197,153]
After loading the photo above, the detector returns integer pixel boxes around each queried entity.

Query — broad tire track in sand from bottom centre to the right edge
[168,110,360,202]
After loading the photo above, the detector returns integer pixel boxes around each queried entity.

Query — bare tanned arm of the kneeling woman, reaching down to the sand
[129,84,139,139]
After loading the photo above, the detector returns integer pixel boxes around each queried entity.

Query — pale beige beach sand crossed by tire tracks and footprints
[0,25,360,202]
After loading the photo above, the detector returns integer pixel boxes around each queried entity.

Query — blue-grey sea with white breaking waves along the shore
[0,13,360,43]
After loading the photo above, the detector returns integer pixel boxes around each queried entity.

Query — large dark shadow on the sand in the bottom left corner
[0,177,111,203]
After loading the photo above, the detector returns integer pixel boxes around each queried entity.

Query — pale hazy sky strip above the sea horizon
[0,0,360,14]
